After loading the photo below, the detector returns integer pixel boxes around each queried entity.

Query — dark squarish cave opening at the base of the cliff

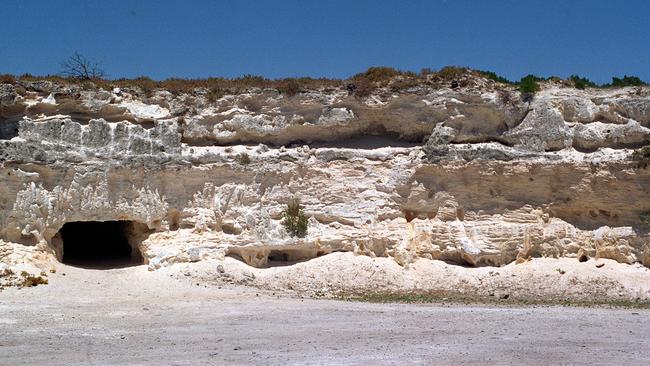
[59,221,144,268]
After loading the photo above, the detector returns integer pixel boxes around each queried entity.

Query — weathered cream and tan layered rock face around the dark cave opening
[0,79,650,269]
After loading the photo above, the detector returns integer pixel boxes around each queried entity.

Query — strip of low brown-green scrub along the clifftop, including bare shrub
[0,53,648,97]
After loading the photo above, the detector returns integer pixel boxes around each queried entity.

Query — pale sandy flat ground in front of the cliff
[0,258,650,365]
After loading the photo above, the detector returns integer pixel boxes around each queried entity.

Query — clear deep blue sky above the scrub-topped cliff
[0,0,650,82]
